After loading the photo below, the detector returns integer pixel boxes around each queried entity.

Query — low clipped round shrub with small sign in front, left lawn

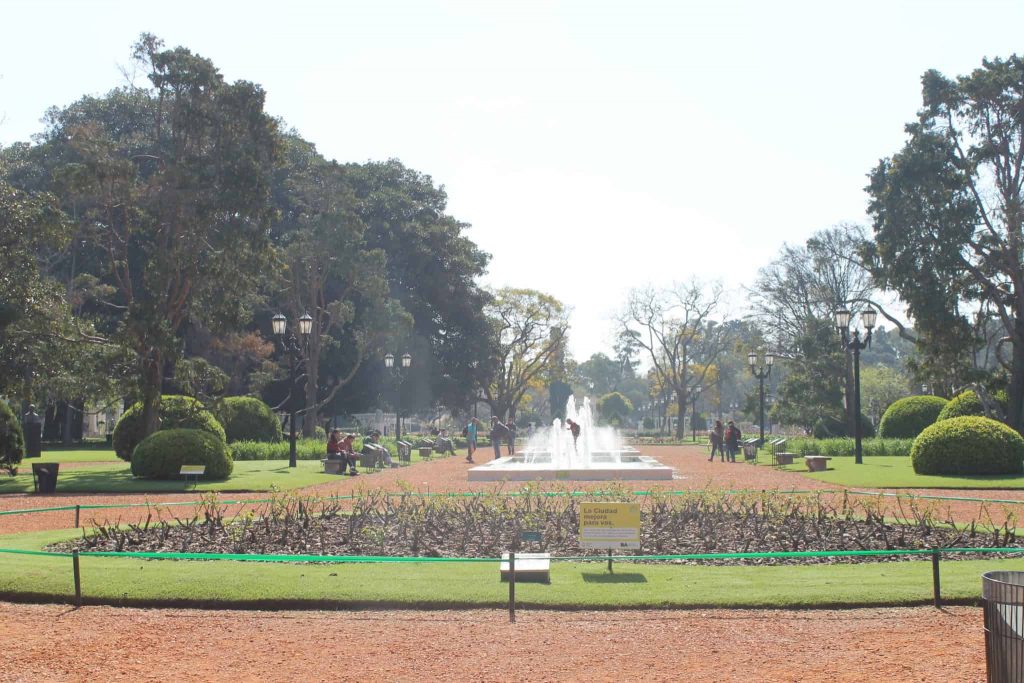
[131,429,234,479]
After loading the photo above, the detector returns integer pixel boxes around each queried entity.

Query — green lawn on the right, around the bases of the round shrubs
[758,451,1024,488]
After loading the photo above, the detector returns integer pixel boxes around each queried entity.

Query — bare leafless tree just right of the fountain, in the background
[618,280,730,438]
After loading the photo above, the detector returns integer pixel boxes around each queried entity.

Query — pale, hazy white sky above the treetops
[0,0,1024,360]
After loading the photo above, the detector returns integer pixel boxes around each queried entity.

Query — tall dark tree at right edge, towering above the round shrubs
[867,55,1024,431]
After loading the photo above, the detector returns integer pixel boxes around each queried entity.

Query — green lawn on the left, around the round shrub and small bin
[0,460,385,494]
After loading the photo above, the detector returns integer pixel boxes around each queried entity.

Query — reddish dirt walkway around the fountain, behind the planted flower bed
[0,446,1024,535]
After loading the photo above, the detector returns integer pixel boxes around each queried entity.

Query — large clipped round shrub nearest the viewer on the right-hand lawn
[910,416,1024,475]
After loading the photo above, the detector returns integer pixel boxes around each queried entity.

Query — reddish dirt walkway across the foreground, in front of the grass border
[0,603,985,683]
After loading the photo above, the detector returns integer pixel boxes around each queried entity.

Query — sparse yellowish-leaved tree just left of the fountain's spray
[483,288,568,420]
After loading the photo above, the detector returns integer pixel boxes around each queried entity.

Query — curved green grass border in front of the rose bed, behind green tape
[0,529,1024,608]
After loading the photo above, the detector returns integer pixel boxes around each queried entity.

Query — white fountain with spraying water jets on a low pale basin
[469,396,673,481]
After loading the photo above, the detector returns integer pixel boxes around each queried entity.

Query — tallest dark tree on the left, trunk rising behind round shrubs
[16,35,278,434]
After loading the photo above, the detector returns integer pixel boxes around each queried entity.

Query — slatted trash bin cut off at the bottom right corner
[981,571,1024,683]
